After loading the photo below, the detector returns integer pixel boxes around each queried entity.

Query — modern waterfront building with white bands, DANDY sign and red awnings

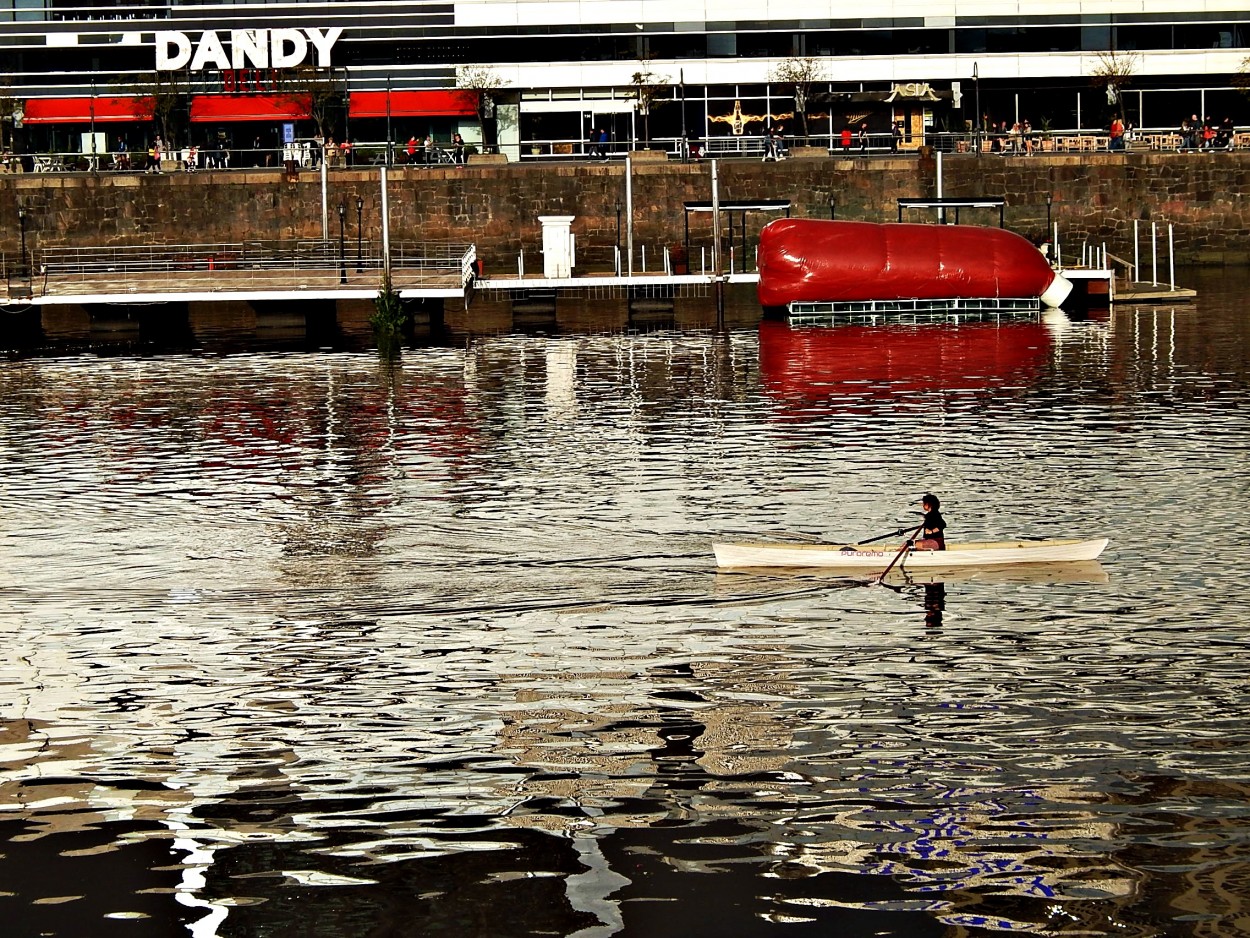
[0,0,1250,159]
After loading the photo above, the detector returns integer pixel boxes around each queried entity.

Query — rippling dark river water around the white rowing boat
[0,273,1250,938]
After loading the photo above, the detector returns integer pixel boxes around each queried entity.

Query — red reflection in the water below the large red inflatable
[760,321,1051,404]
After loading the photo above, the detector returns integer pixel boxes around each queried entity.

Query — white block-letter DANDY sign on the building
[156,26,343,71]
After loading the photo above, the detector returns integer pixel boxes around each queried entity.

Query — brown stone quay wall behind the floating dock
[7,153,1250,270]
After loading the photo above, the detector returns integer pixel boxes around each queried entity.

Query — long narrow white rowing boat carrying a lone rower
[713,538,1108,570]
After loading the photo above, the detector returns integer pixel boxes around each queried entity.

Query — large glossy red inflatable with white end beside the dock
[759,219,1071,306]
